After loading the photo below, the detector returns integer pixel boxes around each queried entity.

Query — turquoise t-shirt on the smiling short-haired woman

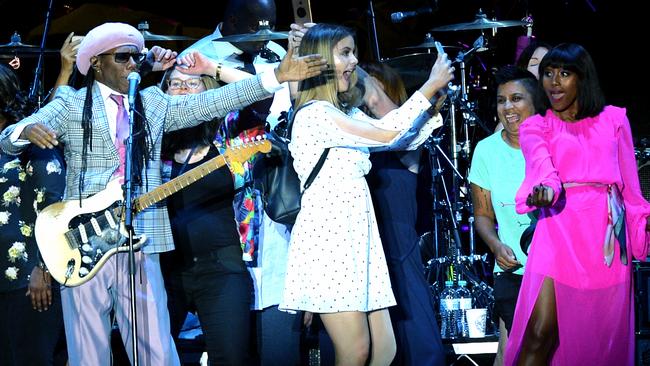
[469,131,530,274]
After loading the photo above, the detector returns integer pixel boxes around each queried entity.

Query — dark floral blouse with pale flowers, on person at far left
[0,146,65,292]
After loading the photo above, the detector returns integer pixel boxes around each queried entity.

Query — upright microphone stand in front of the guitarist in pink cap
[123,95,139,366]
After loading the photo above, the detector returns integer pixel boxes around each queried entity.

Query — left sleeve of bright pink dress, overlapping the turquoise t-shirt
[515,112,562,214]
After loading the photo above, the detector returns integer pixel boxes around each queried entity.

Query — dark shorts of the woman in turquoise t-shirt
[493,272,523,334]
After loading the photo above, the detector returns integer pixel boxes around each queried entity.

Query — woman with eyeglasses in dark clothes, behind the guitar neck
[161,64,263,365]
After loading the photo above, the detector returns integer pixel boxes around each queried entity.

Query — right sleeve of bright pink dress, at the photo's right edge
[608,107,650,260]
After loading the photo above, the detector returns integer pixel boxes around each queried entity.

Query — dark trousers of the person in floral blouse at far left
[0,284,65,366]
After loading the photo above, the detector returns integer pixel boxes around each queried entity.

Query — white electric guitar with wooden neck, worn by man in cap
[34,137,271,287]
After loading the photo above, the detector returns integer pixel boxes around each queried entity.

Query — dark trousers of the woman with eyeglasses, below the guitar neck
[163,246,252,366]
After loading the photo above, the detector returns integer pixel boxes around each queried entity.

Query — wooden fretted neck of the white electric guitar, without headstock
[133,155,227,213]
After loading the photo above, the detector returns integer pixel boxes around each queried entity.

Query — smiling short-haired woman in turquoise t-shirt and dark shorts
[469,65,545,365]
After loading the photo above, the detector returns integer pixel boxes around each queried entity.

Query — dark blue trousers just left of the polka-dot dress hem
[255,306,302,366]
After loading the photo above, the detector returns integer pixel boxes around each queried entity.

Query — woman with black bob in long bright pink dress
[505,44,650,365]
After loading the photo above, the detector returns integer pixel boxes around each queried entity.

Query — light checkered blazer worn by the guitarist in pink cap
[0,76,270,253]
